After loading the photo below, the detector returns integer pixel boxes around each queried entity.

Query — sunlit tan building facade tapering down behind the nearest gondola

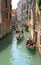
[28,0,36,41]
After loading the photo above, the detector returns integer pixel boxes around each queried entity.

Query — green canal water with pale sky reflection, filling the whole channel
[0,31,41,65]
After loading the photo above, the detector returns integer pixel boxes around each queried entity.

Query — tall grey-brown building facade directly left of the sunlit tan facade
[21,0,28,25]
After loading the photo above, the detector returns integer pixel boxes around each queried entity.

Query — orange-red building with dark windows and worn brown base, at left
[0,0,12,38]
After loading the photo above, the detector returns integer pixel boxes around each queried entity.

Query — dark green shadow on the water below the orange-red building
[0,33,13,52]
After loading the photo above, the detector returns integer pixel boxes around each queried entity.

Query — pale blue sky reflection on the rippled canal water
[11,34,30,65]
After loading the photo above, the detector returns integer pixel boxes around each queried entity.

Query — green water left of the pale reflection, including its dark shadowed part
[0,33,14,65]
